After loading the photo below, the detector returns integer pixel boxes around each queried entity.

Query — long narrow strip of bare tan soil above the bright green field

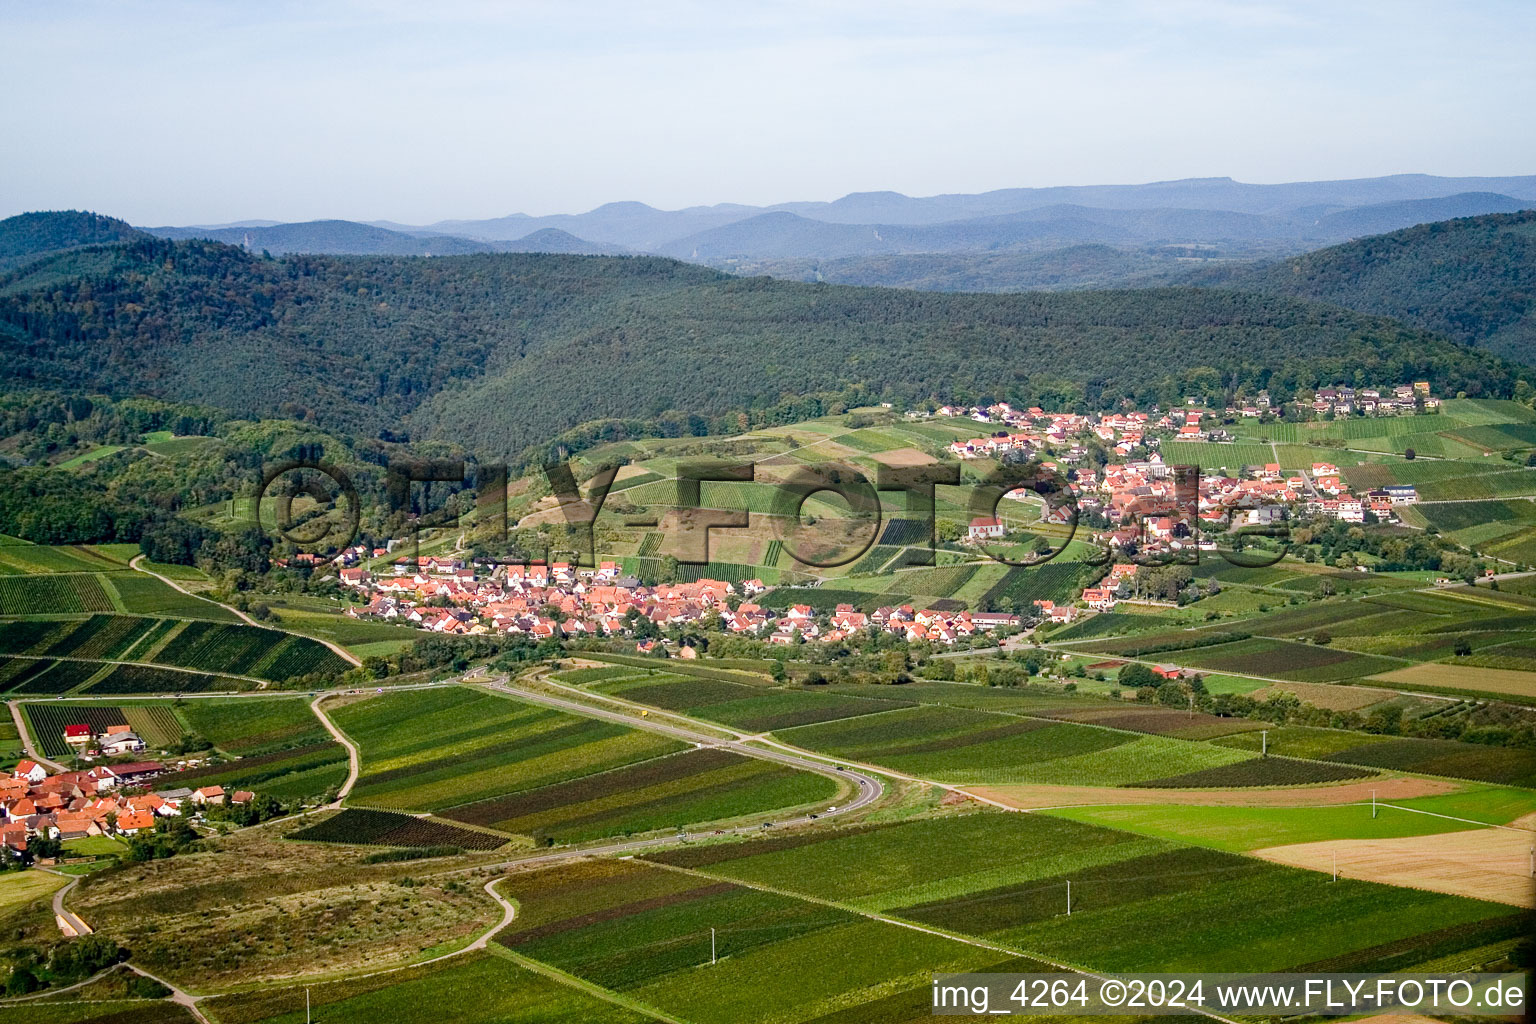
[966,777,1461,809]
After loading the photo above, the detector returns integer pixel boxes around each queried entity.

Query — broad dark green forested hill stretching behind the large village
[0,231,1514,456]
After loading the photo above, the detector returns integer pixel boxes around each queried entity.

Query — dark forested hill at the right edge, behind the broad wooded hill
[1227,210,1536,364]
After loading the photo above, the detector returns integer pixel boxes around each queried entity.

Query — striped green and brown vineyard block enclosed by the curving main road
[333,680,840,843]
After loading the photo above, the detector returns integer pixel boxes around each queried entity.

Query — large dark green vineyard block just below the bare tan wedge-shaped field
[650,809,1522,970]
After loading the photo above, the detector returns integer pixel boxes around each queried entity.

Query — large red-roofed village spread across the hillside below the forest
[327,381,1439,656]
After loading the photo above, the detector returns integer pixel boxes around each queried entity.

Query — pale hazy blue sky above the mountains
[0,0,1536,226]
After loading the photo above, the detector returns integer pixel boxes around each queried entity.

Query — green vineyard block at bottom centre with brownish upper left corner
[496,860,1023,1024]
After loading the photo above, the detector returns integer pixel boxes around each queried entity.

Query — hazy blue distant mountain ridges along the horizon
[113,175,1536,292]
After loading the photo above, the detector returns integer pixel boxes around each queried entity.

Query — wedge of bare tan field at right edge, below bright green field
[1253,829,1536,907]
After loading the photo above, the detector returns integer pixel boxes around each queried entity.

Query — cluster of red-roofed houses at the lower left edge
[0,760,242,857]
